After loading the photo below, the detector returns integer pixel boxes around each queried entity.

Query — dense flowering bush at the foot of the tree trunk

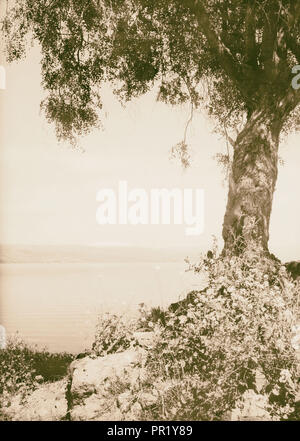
[144,244,299,420]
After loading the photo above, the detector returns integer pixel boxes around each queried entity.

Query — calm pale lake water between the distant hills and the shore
[0,262,205,352]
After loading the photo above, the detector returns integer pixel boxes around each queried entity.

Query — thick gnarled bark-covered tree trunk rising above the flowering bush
[223,110,282,254]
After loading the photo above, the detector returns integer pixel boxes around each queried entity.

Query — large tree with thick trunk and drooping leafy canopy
[3,0,300,252]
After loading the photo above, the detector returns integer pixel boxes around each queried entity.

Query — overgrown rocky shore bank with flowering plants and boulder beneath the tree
[0,242,300,420]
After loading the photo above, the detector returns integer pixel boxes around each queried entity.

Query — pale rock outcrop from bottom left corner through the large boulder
[0,332,153,421]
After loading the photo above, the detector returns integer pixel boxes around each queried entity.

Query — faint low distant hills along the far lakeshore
[0,245,200,263]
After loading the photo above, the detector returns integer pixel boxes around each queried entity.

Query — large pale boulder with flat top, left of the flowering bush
[67,348,146,421]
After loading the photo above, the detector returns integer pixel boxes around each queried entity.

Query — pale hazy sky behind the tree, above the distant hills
[0,39,300,260]
